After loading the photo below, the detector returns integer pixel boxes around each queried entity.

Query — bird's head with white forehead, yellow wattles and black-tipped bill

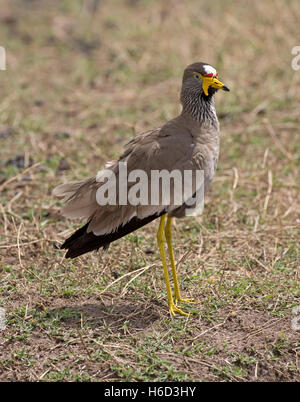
[182,62,229,97]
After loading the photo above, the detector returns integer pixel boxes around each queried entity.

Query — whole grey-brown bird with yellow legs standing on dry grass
[53,62,229,316]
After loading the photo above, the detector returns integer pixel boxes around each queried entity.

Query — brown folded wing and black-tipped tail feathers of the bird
[53,118,209,258]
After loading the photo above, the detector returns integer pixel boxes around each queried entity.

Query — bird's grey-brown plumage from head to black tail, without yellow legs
[53,63,228,258]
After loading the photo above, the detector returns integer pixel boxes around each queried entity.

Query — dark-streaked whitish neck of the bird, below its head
[180,88,218,127]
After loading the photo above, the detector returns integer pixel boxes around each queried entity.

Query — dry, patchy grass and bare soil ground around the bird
[0,0,300,381]
